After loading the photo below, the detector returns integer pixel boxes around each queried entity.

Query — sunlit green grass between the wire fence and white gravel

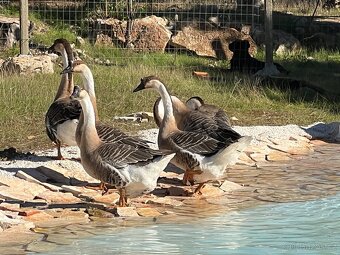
[0,54,340,150]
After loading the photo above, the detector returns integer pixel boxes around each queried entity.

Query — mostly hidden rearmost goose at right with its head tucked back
[186,96,231,127]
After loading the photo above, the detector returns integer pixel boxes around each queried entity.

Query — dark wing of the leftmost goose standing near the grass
[45,98,81,141]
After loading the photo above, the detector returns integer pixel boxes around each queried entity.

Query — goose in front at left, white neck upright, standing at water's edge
[72,86,175,206]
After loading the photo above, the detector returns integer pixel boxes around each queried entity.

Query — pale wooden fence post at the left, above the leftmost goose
[20,0,29,55]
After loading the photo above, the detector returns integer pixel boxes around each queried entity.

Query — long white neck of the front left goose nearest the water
[79,97,101,152]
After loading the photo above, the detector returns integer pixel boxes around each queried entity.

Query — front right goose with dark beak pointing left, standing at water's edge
[133,76,252,194]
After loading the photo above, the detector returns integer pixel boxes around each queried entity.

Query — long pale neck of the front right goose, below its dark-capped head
[157,82,177,128]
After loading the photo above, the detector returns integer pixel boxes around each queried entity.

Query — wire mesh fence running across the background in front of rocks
[0,0,340,76]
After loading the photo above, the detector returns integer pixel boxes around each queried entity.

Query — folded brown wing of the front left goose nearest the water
[97,143,166,169]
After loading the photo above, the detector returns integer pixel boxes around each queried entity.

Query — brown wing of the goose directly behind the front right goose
[183,110,241,142]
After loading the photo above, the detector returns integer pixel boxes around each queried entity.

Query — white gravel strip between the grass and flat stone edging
[0,122,340,178]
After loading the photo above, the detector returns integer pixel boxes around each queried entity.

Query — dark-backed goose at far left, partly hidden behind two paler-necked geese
[45,38,81,160]
